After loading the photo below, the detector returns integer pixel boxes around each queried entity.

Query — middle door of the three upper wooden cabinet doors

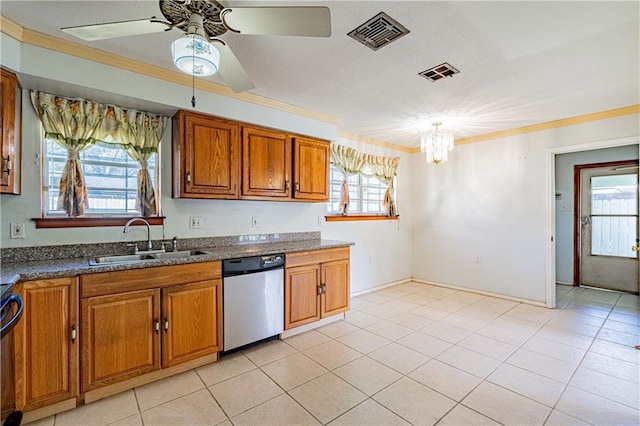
[242,126,291,199]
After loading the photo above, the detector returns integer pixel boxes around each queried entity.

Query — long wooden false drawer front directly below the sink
[80,261,222,298]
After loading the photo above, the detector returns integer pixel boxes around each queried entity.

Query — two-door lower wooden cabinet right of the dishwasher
[284,247,350,330]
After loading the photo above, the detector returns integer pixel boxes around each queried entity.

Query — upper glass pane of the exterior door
[591,173,638,215]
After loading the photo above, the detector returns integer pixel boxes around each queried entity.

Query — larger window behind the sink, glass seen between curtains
[43,138,158,217]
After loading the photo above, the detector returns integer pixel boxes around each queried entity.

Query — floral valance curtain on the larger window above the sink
[31,90,167,217]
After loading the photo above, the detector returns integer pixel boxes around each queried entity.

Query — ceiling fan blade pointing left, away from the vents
[61,18,168,41]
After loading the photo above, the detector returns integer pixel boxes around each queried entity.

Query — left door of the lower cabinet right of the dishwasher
[284,264,320,330]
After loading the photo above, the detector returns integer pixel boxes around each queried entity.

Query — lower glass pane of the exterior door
[591,216,638,258]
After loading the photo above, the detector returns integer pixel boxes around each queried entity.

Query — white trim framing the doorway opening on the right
[545,136,640,308]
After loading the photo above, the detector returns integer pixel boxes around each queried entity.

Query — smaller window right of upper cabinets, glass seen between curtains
[327,163,387,215]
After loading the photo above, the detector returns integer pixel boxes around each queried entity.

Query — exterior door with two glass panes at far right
[579,166,639,293]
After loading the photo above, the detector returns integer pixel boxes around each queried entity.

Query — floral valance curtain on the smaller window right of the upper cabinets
[331,144,400,217]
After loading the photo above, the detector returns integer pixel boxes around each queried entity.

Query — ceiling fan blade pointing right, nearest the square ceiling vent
[220,6,331,37]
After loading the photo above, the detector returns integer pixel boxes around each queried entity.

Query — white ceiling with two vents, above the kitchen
[0,0,640,147]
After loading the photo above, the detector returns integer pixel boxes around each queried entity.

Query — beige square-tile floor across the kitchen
[25,282,640,426]
